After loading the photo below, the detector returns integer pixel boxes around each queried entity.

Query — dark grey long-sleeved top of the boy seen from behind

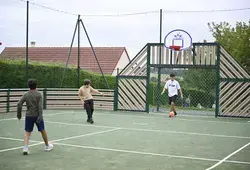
[17,90,43,117]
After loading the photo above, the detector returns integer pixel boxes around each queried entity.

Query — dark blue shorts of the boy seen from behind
[25,116,44,132]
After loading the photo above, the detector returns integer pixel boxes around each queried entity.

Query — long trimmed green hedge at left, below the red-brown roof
[0,59,115,89]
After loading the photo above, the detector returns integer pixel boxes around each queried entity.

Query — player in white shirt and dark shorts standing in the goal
[161,74,183,115]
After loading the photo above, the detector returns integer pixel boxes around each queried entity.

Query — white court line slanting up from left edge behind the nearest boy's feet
[0,128,120,153]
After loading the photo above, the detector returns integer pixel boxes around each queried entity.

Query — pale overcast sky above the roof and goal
[0,0,250,59]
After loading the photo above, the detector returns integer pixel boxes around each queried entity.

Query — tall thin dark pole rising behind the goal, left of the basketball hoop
[156,9,162,112]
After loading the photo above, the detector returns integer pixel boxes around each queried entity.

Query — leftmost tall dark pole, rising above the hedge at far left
[26,1,29,82]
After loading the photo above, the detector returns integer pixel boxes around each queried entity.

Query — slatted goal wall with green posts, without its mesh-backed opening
[114,43,250,117]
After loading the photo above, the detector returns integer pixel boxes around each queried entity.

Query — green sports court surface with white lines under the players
[0,110,250,170]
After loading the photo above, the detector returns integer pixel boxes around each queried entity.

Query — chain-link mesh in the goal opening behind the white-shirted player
[150,68,216,115]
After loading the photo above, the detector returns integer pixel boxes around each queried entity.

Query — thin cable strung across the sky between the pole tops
[16,0,250,17]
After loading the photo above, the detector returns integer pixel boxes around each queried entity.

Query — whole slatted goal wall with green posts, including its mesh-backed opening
[114,43,250,117]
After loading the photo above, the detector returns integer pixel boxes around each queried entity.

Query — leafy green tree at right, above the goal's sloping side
[208,20,250,72]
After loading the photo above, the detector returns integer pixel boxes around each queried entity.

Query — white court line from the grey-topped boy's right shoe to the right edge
[55,143,250,165]
